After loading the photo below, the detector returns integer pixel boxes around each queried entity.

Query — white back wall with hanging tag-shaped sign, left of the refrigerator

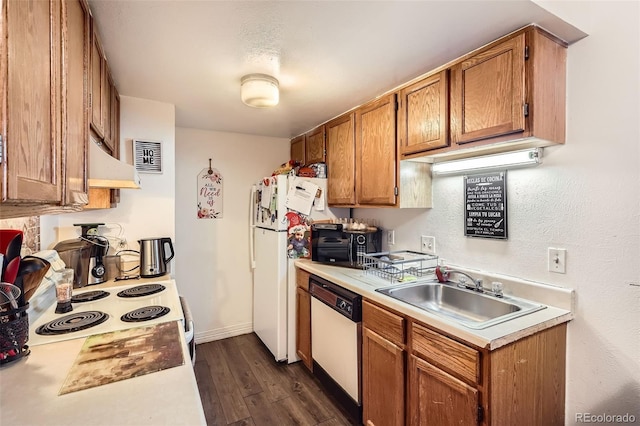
[175,128,289,343]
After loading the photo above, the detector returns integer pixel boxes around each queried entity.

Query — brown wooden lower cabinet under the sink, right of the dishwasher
[362,300,566,426]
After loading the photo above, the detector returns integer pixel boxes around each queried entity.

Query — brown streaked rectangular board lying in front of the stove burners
[59,321,184,395]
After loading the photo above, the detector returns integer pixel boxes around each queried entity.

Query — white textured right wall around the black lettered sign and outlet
[356,2,640,424]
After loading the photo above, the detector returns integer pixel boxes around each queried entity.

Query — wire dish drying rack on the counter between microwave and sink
[362,250,438,282]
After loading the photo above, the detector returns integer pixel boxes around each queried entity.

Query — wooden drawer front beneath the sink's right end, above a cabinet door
[411,324,480,383]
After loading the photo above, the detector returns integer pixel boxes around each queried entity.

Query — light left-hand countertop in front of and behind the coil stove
[0,275,206,426]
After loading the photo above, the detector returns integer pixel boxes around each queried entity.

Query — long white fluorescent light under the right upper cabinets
[431,148,542,175]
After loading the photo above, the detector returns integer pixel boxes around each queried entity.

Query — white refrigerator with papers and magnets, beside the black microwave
[250,175,348,363]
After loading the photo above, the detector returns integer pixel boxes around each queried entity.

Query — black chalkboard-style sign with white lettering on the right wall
[464,171,507,239]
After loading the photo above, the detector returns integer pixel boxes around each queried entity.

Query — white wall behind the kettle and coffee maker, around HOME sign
[40,96,175,263]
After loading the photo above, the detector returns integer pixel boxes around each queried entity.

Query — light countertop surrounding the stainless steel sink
[295,259,575,350]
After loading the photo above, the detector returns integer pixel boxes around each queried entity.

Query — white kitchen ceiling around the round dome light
[89,0,584,138]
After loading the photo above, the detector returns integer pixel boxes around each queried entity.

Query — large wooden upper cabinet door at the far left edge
[0,0,62,204]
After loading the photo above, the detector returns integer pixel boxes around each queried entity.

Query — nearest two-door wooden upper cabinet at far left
[0,0,89,218]
